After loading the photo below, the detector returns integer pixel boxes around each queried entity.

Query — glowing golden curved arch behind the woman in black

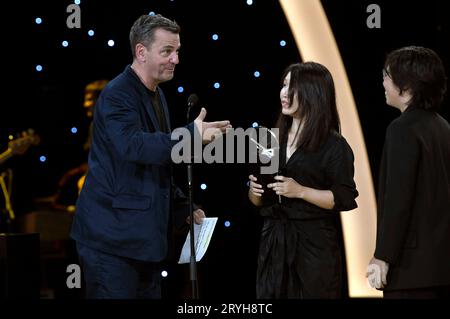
[280,0,381,297]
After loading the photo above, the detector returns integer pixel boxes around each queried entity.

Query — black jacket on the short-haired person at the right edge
[375,107,450,290]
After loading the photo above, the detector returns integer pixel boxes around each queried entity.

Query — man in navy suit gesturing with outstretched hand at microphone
[71,15,230,299]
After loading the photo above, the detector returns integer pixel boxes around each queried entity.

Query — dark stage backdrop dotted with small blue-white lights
[0,0,450,298]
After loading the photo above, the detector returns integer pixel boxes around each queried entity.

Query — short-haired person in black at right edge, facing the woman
[367,47,450,298]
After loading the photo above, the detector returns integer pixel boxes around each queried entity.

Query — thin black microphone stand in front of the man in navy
[186,103,198,299]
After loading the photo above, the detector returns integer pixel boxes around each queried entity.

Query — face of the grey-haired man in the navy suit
[145,29,181,84]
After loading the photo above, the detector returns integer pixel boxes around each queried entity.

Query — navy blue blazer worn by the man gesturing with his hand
[71,66,193,262]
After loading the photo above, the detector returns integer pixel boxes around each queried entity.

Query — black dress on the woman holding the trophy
[256,133,358,298]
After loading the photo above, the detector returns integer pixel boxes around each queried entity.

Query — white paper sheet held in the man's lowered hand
[178,217,217,264]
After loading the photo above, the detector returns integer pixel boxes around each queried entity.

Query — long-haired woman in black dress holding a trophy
[249,62,358,298]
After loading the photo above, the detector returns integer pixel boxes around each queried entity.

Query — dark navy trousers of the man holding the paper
[77,243,161,299]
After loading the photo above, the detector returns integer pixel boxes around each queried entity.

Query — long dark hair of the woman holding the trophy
[276,62,340,151]
